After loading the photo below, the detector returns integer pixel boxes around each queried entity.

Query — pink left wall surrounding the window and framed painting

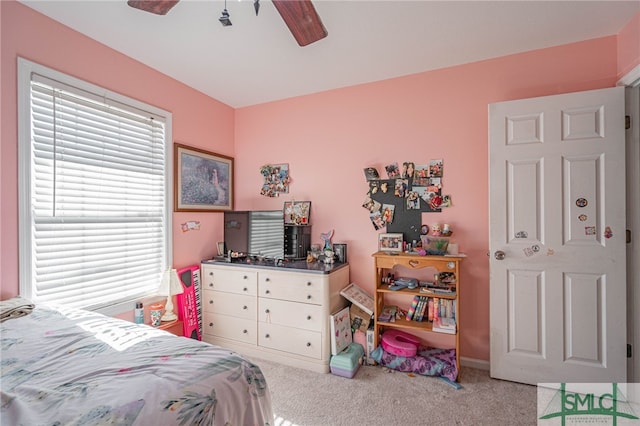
[0,1,235,299]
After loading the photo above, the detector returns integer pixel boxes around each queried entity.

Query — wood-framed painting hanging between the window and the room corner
[173,143,233,212]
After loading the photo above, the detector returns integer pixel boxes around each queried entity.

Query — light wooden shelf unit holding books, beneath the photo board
[372,252,465,371]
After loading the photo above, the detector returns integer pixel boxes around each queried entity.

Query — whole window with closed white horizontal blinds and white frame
[18,58,172,313]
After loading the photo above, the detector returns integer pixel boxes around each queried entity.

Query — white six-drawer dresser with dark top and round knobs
[201,261,349,373]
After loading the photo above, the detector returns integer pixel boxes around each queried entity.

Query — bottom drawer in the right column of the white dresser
[258,322,322,359]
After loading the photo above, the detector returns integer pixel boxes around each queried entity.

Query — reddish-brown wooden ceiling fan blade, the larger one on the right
[272,0,327,46]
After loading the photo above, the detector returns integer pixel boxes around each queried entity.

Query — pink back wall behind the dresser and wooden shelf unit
[235,37,617,360]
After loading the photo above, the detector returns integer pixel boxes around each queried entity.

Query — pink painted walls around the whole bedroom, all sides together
[0,1,640,360]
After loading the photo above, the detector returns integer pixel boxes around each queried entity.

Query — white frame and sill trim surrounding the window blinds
[17,57,173,315]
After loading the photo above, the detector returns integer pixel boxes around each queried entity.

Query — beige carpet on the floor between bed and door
[252,358,537,426]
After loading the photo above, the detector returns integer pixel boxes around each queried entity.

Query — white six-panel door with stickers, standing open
[489,87,627,384]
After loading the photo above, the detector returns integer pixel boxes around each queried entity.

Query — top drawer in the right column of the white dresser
[258,272,325,305]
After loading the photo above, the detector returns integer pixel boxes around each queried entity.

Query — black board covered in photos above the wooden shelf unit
[362,159,451,230]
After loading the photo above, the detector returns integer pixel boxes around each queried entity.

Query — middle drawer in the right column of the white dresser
[258,297,324,331]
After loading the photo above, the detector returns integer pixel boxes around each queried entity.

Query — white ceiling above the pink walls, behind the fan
[21,0,640,108]
